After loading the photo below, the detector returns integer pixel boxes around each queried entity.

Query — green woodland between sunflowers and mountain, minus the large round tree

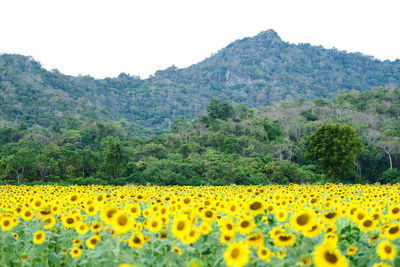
[0,87,400,185]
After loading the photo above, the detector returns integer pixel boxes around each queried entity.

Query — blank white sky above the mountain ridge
[0,0,400,78]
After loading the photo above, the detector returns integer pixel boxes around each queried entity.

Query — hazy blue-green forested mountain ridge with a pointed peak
[0,30,400,135]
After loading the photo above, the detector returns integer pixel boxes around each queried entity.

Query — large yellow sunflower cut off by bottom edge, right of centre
[313,244,348,267]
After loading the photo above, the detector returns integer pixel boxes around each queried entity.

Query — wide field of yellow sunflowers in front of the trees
[0,184,400,267]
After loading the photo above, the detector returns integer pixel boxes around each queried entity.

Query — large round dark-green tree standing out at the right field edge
[306,124,362,178]
